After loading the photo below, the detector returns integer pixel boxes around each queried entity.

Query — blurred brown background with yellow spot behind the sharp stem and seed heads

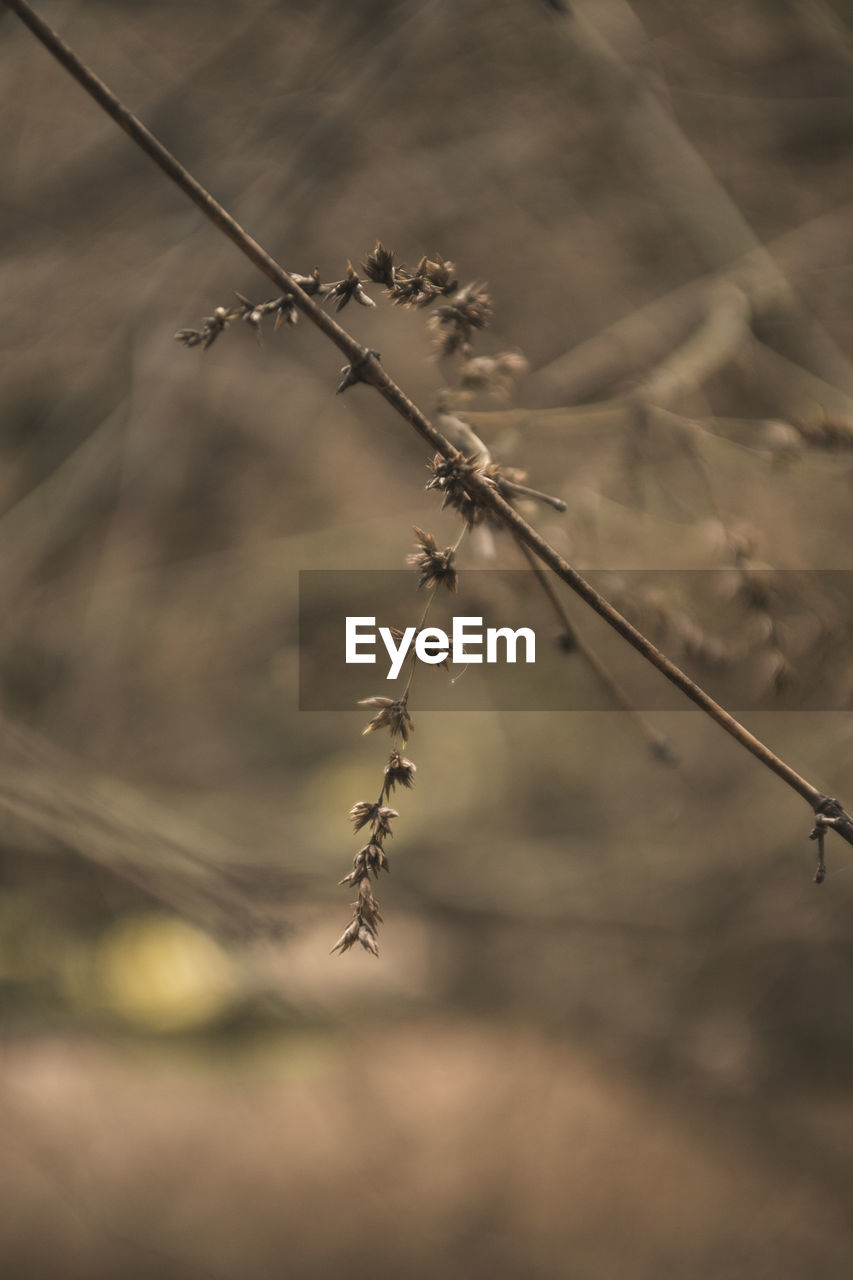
[0,0,853,1280]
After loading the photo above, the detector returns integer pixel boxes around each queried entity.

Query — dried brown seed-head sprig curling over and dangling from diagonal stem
[175,241,578,956]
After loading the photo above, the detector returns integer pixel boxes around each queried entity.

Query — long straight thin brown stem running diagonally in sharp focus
[4,0,853,860]
